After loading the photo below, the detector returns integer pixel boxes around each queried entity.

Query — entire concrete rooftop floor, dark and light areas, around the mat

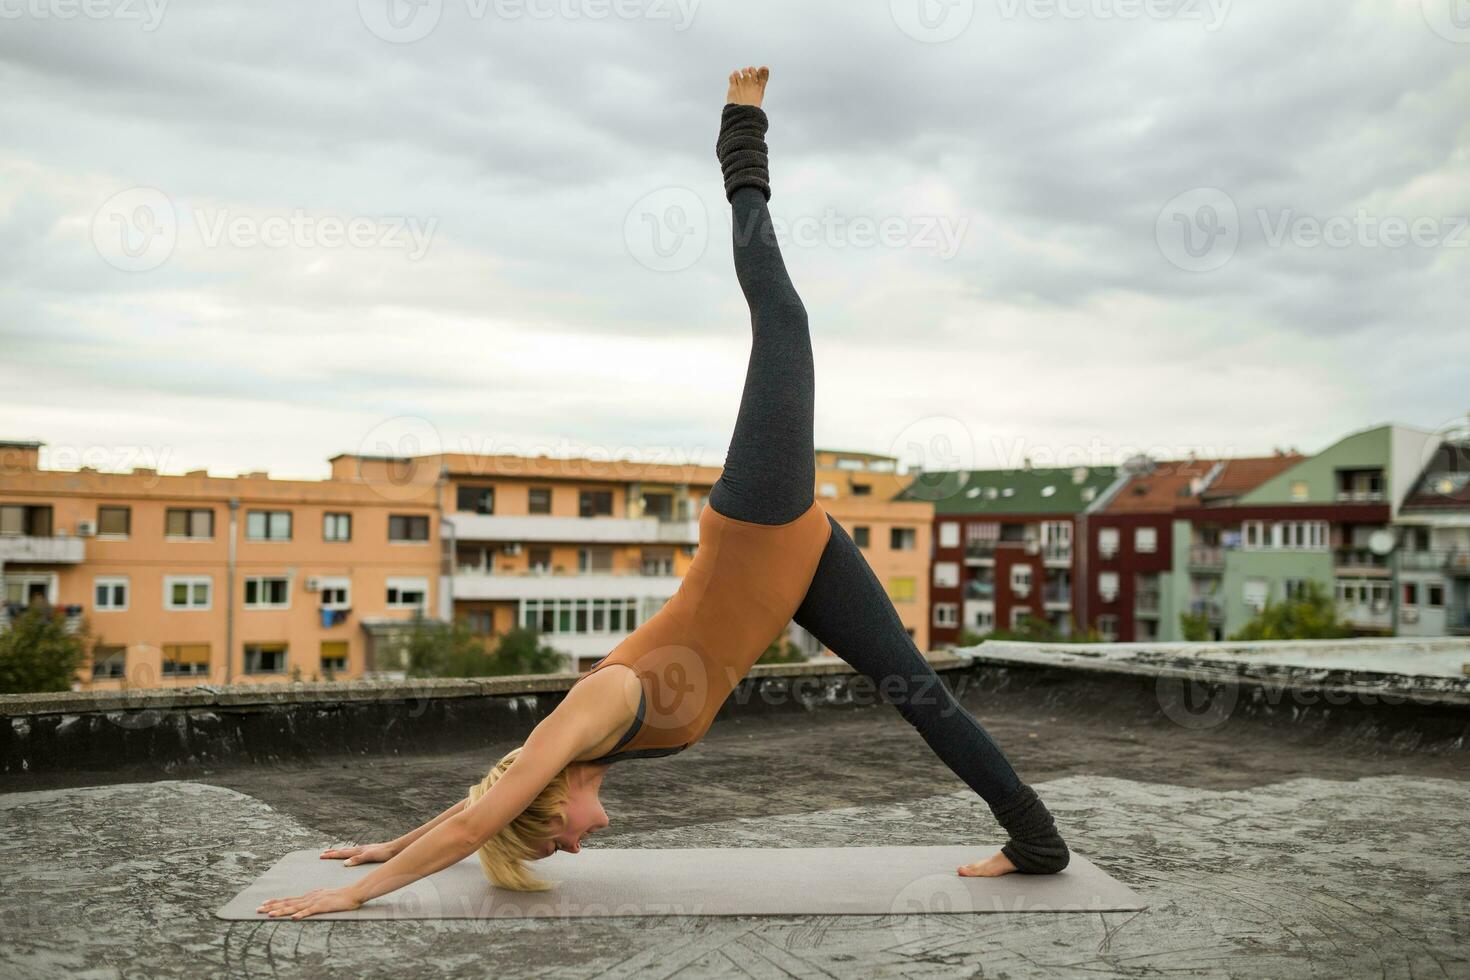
[0,675,1470,979]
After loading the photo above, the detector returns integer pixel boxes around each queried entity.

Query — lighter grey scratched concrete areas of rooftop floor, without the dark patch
[0,777,1470,977]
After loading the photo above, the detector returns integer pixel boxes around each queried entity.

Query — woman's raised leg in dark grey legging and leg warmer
[710,82,816,525]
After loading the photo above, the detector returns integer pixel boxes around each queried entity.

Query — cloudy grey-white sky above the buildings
[0,0,1470,476]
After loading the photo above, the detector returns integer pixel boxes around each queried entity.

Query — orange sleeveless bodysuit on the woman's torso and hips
[573,501,832,763]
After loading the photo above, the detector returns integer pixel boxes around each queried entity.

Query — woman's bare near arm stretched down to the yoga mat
[256,670,638,918]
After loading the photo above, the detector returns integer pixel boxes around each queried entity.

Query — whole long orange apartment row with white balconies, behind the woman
[0,442,932,688]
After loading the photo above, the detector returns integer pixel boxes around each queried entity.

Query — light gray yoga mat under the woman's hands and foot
[216,845,1147,921]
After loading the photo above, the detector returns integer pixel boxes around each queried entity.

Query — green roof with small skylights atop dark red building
[894,466,1117,514]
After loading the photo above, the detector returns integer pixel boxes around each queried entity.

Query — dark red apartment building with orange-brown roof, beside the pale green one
[1078,453,1305,642]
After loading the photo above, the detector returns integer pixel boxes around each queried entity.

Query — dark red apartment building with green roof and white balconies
[900,466,1117,644]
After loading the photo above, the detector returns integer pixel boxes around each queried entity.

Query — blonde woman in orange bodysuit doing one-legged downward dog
[259,68,1069,918]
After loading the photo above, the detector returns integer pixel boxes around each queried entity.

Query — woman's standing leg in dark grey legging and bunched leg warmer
[794,517,1069,874]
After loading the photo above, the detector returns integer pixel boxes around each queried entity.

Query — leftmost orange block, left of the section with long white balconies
[0,442,440,689]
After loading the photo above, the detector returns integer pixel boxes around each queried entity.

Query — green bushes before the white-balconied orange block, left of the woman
[398,616,563,677]
